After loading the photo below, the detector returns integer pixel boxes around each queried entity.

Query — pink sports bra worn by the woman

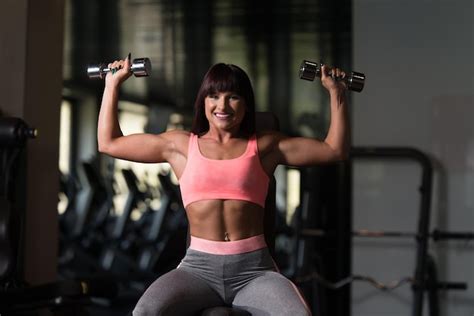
[179,134,269,207]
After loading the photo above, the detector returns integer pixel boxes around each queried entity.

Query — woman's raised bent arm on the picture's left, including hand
[97,57,187,163]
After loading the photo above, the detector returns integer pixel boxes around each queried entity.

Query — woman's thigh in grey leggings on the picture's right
[233,271,311,316]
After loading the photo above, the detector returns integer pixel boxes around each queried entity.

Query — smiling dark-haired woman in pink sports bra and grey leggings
[98,55,348,316]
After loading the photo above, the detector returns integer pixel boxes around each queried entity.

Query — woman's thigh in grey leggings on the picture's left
[133,269,223,316]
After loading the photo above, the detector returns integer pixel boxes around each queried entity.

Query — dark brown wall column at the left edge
[0,0,64,284]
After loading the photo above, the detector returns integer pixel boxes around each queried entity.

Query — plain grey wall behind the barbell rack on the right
[352,0,474,316]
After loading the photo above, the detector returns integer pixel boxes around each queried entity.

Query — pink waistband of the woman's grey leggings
[189,234,267,255]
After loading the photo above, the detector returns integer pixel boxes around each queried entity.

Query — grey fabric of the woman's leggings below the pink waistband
[133,248,311,316]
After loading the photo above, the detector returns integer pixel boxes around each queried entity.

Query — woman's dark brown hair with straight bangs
[191,63,255,136]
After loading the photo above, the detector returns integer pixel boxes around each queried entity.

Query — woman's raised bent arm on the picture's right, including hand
[276,66,350,166]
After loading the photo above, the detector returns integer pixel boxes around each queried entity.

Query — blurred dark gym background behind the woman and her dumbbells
[0,0,474,316]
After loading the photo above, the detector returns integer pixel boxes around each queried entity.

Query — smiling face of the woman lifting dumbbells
[204,92,246,131]
